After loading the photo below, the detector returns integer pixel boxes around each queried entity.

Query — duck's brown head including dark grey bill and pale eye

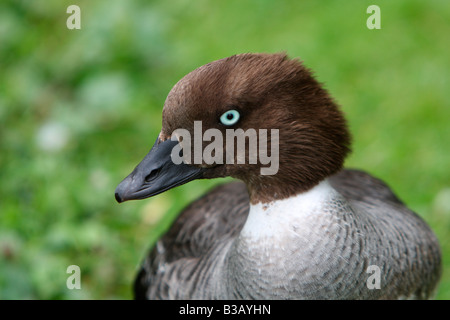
[116,54,350,204]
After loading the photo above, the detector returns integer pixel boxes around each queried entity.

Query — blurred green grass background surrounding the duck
[0,0,450,299]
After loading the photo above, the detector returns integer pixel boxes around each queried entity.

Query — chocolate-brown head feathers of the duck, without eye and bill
[160,54,350,203]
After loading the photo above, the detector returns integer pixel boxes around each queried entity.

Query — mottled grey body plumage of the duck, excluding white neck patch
[134,170,441,299]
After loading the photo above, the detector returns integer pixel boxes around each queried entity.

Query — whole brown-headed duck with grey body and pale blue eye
[115,53,441,300]
